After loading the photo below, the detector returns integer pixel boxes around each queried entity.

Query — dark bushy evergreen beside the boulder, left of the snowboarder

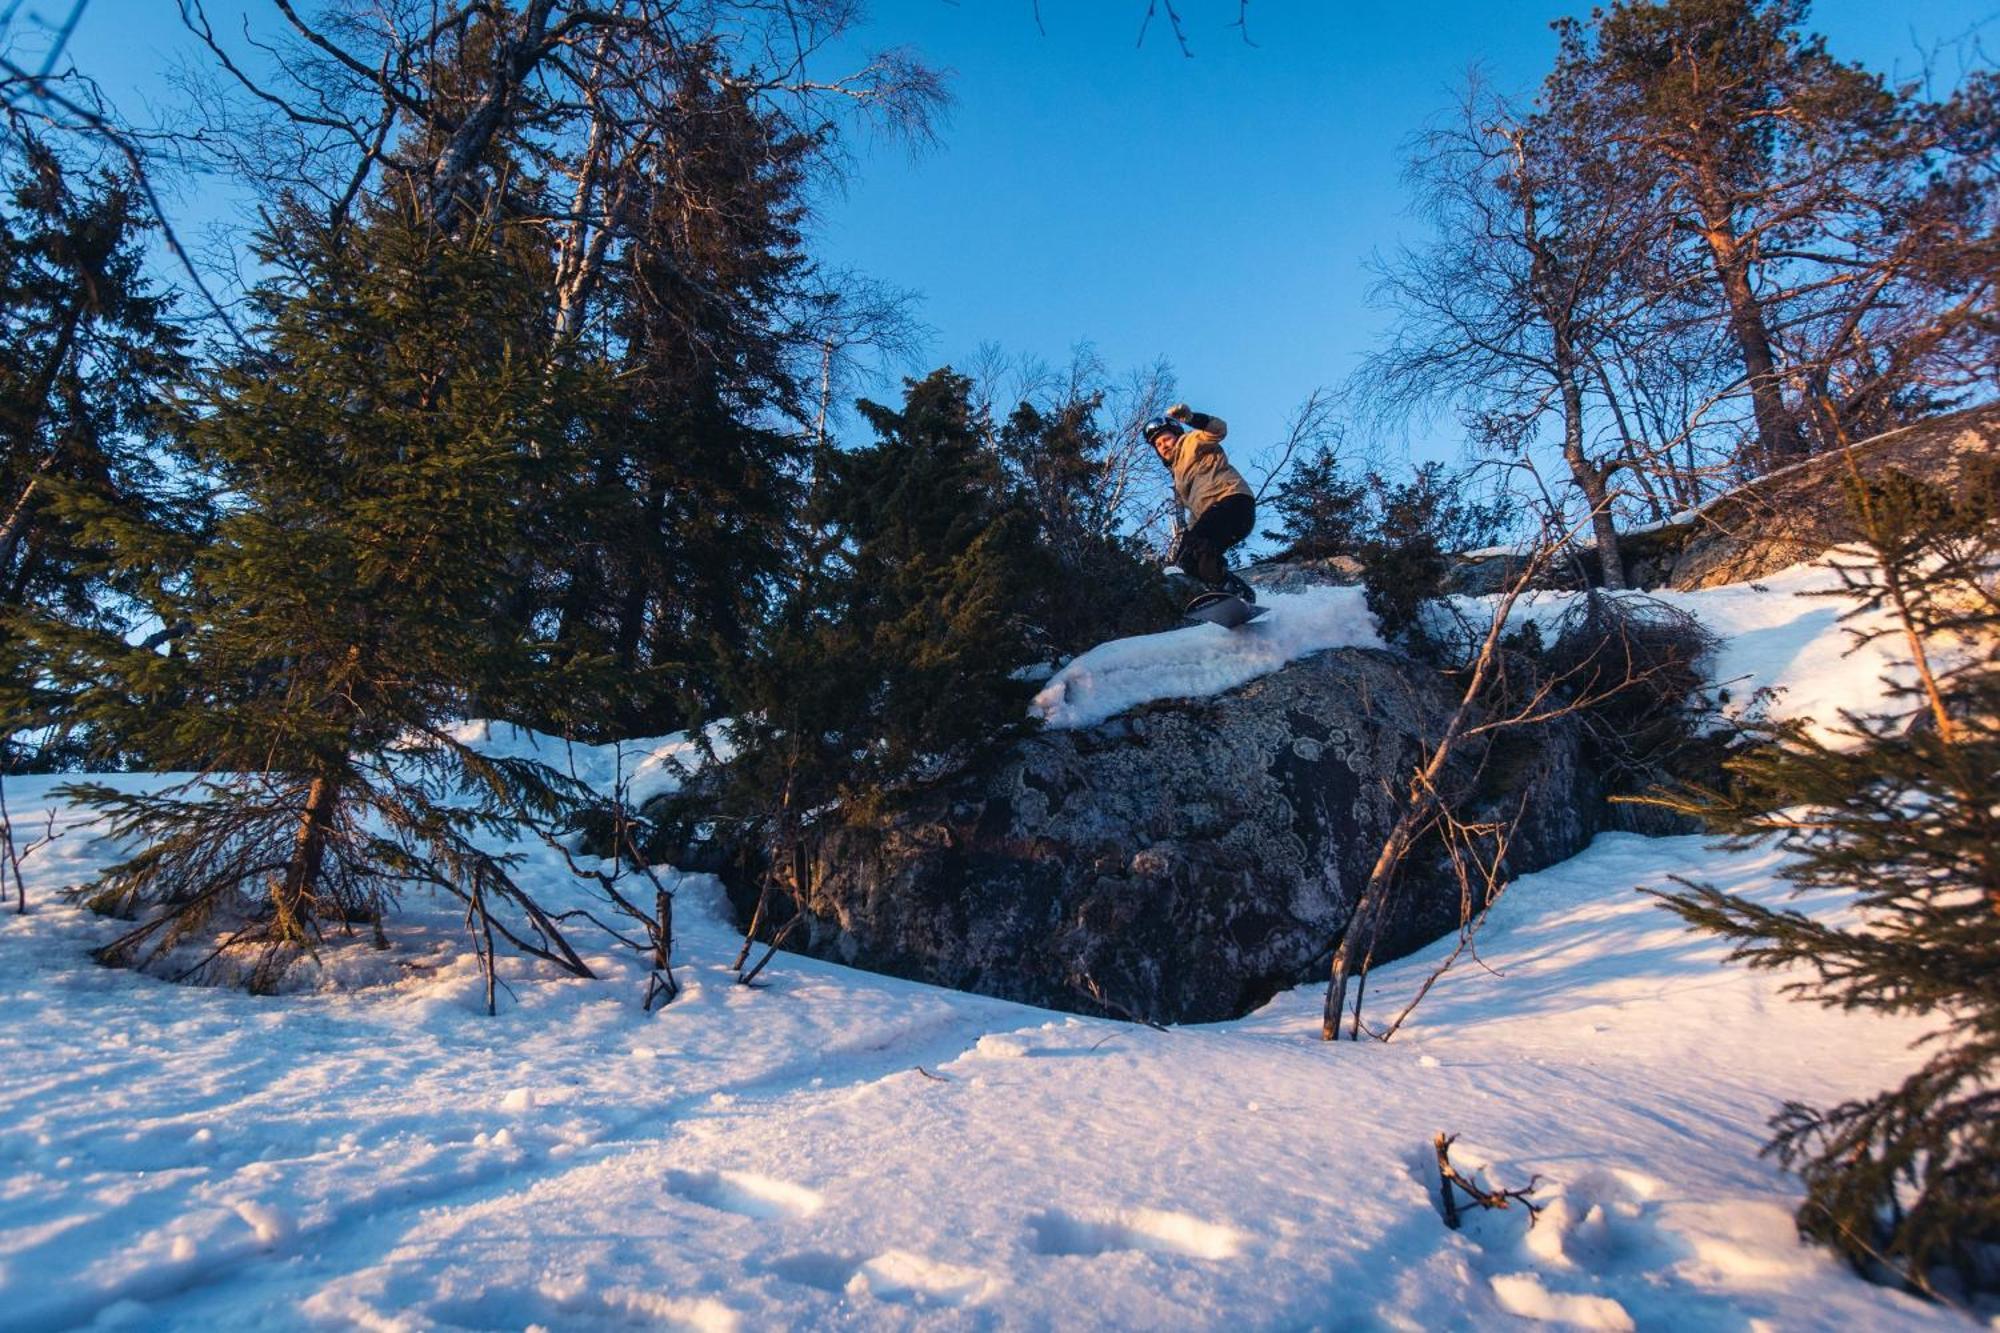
[736,370,1052,837]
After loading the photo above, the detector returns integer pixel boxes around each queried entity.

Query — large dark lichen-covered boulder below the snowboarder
[732,648,1602,1023]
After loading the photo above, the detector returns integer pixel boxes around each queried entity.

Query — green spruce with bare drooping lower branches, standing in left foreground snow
[13,206,590,987]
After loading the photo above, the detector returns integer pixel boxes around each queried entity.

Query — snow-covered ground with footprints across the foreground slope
[0,556,1966,1333]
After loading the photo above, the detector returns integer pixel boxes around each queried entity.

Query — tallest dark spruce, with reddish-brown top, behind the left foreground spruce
[530,62,820,735]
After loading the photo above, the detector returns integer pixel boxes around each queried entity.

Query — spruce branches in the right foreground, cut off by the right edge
[1662,458,2000,1295]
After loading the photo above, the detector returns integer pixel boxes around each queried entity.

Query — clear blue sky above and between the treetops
[47,0,2000,466]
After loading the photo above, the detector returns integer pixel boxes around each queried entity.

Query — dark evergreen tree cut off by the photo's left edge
[0,140,195,767]
